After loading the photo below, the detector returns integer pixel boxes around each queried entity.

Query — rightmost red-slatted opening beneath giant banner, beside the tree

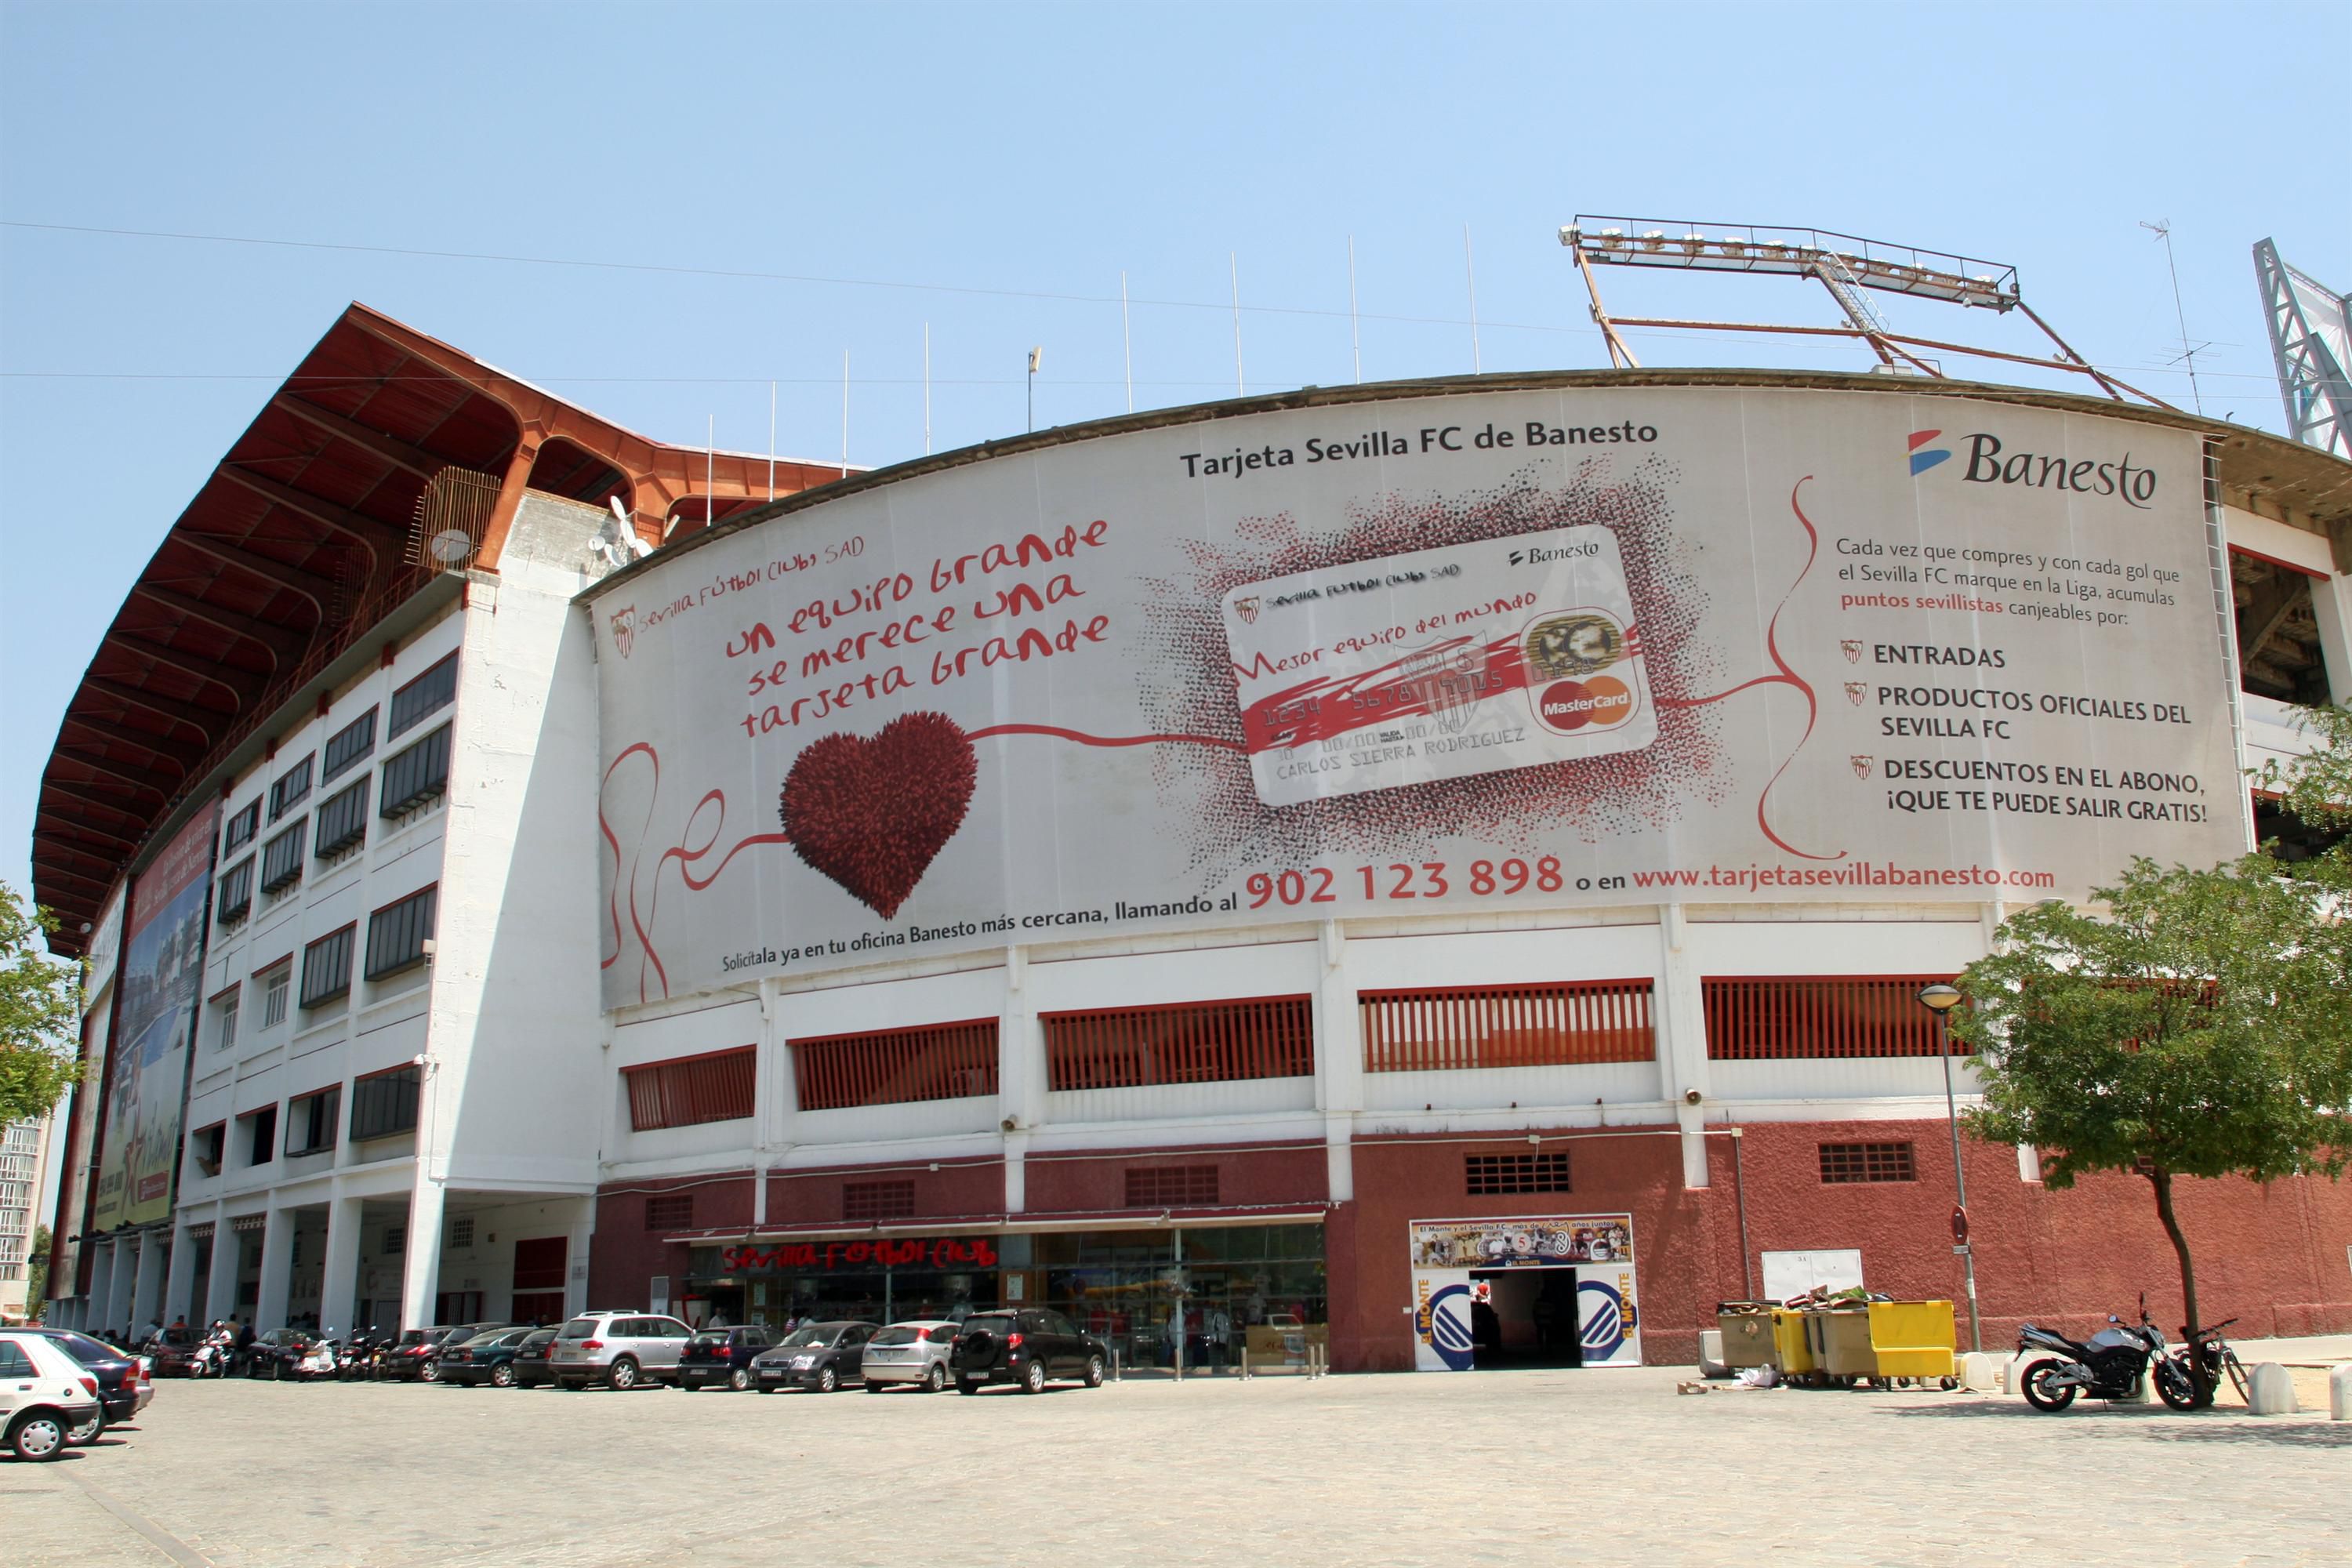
[1700,975,1969,1062]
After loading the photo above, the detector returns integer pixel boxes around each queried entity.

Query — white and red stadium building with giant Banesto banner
[35,297,2352,1370]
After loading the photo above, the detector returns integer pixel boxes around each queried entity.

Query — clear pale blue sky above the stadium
[0,0,2352,945]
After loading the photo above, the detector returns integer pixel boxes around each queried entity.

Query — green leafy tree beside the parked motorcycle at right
[1952,710,2352,1382]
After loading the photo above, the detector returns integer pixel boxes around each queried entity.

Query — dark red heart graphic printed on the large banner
[783,713,981,919]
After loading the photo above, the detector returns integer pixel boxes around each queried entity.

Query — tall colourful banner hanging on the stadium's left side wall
[92,806,219,1229]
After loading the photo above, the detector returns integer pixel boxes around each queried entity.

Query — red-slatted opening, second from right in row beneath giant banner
[1359,980,1658,1072]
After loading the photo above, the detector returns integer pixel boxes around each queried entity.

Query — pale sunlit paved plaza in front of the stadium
[0,1368,2352,1568]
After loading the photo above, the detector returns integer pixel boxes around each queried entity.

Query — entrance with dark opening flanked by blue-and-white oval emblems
[1409,1213,1642,1373]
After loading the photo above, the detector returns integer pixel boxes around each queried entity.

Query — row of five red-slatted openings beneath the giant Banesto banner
[626,975,1962,1131]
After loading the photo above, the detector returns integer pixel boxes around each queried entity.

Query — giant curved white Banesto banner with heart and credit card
[590,388,2246,1004]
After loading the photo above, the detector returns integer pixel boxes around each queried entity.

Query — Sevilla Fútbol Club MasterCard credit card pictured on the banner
[1225,527,1658,806]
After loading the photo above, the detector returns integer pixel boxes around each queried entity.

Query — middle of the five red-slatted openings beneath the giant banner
[1042,996,1315,1088]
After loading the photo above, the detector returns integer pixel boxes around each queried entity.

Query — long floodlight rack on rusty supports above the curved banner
[1559,214,2171,409]
